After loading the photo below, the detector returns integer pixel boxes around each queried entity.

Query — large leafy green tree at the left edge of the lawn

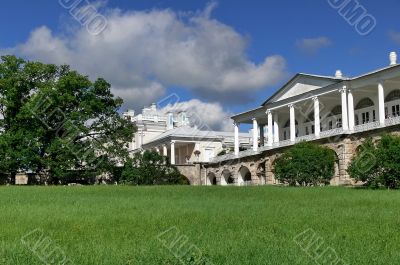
[0,56,135,183]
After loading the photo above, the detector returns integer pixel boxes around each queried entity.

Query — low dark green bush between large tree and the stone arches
[121,151,189,185]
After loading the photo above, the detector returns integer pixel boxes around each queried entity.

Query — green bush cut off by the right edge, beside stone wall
[348,134,400,189]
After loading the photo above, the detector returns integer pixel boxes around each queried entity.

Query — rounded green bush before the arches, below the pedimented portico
[274,142,336,186]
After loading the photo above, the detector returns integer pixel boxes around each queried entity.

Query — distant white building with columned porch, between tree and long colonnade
[123,104,252,165]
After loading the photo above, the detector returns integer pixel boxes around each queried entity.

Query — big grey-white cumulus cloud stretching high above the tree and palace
[7,2,286,108]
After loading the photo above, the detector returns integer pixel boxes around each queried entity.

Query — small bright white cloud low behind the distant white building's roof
[162,99,233,131]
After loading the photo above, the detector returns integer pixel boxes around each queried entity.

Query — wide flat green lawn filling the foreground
[0,186,400,264]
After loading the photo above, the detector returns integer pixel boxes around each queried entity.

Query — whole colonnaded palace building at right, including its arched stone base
[201,52,400,185]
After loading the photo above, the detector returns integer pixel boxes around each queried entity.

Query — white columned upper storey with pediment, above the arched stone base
[213,53,400,162]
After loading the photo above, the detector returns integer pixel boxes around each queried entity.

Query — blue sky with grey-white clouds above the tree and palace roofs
[0,0,400,127]
